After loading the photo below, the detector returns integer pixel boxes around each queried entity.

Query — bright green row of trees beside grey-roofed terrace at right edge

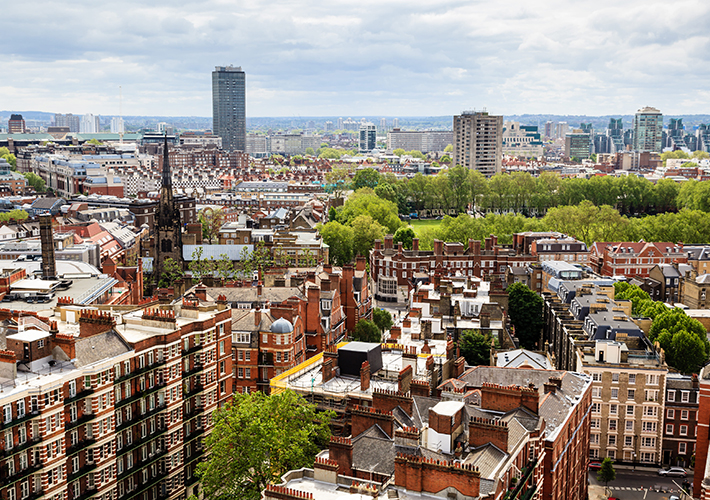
[614,282,710,373]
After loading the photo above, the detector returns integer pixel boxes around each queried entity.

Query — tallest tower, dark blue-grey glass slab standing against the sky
[212,66,247,151]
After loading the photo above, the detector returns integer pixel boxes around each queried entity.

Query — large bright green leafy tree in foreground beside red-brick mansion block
[197,390,334,500]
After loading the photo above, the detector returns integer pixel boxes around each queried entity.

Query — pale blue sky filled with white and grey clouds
[0,0,710,117]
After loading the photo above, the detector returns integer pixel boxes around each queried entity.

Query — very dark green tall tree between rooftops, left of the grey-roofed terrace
[508,283,544,349]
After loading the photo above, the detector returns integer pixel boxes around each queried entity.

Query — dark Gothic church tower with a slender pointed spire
[153,134,183,285]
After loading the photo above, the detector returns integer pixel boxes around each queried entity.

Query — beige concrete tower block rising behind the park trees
[453,111,503,177]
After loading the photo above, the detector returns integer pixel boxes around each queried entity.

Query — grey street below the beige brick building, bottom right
[589,468,693,500]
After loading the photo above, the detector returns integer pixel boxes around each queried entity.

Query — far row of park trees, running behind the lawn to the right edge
[328,166,710,215]
